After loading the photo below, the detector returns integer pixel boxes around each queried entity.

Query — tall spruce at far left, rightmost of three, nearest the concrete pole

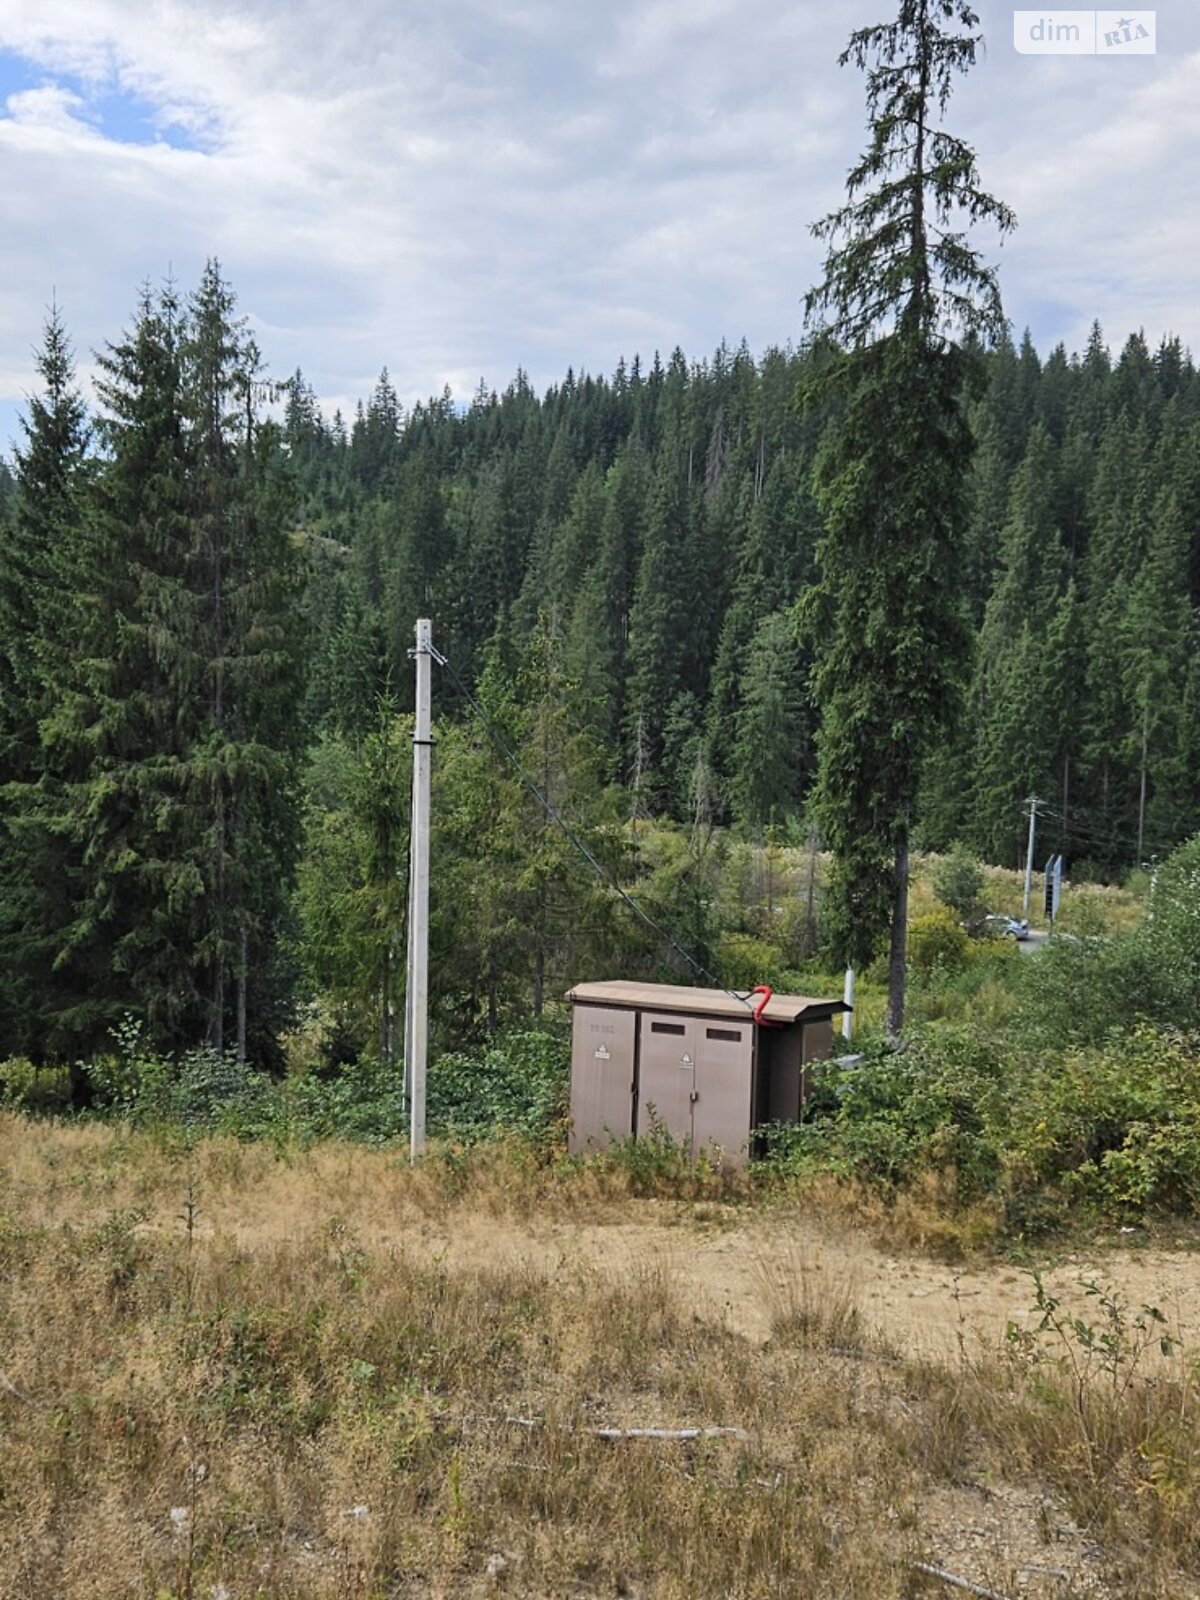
[182,261,307,1058]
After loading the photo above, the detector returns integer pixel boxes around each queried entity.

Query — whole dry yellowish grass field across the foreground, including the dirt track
[0,1117,1200,1600]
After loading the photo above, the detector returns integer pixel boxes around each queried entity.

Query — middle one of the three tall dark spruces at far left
[35,288,192,1053]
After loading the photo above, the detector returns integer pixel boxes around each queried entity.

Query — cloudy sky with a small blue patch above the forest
[0,0,1200,448]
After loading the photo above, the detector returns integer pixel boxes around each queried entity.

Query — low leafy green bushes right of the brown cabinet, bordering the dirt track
[771,1024,1200,1235]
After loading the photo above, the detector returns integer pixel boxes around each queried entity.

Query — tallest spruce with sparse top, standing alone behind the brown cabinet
[806,0,1013,1034]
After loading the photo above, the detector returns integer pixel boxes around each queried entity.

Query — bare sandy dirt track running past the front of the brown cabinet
[206,1152,1200,1357]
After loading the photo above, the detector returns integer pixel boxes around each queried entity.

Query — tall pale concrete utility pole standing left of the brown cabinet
[405,618,434,1160]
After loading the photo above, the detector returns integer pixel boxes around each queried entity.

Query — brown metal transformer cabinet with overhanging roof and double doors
[568,982,846,1165]
